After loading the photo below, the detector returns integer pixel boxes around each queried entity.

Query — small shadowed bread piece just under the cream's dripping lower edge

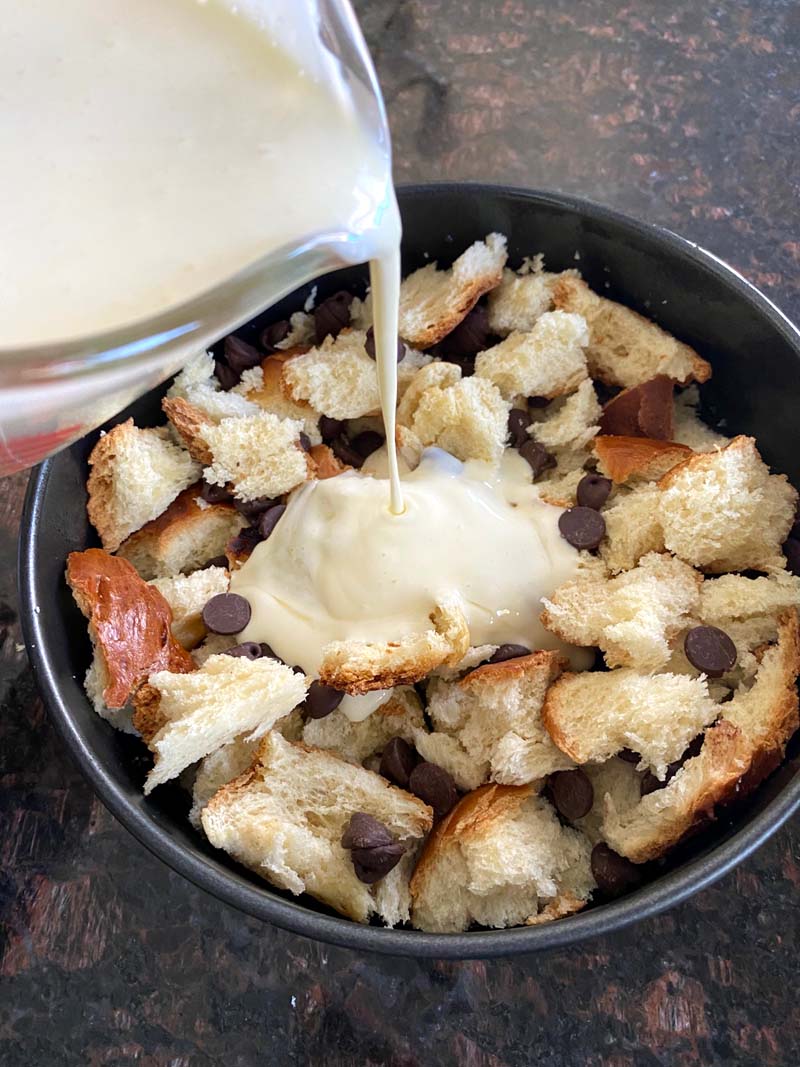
[303,687,425,763]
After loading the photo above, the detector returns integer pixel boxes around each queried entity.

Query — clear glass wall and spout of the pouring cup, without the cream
[0,0,394,475]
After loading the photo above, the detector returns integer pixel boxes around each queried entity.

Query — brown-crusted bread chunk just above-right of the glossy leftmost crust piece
[117,485,246,580]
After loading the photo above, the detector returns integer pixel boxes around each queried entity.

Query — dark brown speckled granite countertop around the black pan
[0,0,800,1067]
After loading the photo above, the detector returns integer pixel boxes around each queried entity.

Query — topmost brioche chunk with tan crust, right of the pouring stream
[400,234,507,349]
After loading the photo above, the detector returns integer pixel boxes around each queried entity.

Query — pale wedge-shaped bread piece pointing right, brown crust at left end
[133,655,308,794]
